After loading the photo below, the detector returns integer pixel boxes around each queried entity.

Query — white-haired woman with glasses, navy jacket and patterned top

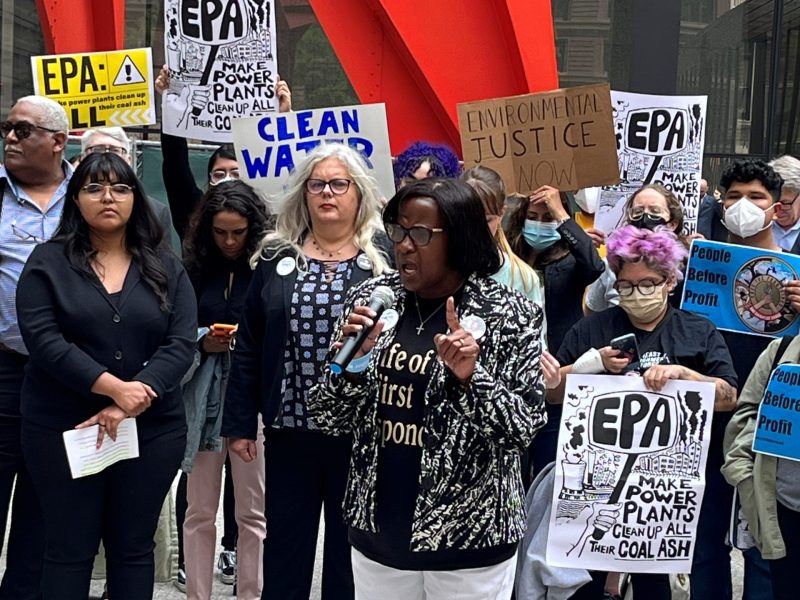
[222,144,389,600]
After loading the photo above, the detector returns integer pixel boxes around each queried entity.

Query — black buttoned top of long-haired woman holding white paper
[17,242,197,431]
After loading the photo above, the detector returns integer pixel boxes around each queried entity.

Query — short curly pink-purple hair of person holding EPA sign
[606,225,689,281]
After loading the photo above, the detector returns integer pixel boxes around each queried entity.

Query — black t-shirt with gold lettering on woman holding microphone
[349,294,516,571]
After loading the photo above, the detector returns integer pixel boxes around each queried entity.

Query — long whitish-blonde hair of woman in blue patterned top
[250,143,389,275]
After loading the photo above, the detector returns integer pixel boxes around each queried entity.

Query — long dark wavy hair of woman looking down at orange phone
[183,181,269,277]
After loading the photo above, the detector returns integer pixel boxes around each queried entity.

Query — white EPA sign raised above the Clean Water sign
[162,0,278,143]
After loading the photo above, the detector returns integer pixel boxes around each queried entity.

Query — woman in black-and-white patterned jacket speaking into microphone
[308,179,544,599]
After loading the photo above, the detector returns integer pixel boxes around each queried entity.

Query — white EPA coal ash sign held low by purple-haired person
[547,375,715,573]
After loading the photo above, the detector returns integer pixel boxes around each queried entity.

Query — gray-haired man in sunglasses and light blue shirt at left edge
[0,96,73,600]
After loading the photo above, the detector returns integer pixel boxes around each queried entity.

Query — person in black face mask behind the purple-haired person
[584,184,689,315]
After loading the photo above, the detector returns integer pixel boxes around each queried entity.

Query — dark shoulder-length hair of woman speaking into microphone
[383,177,502,277]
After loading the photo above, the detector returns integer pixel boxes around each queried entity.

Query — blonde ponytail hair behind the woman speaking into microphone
[461,165,541,294]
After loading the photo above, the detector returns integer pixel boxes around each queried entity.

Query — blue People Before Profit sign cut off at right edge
[753,364,800,460]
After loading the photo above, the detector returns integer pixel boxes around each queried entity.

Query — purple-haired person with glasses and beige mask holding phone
[547,225,736,600]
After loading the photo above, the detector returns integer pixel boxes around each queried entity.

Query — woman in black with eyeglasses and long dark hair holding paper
[17,154,197,600]
